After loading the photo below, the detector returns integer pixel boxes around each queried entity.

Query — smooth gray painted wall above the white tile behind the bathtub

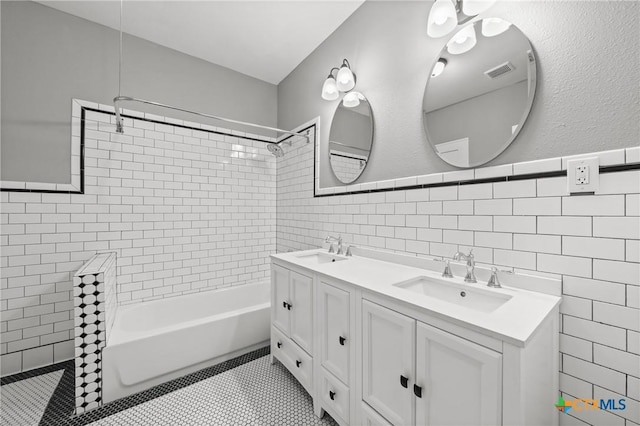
[1,1,277,183]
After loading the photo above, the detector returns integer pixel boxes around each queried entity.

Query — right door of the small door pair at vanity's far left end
[289,271,313,353]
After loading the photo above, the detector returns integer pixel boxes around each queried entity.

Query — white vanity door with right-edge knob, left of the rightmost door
[362,300,416,425]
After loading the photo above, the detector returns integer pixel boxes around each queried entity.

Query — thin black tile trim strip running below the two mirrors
[313,162,640,198]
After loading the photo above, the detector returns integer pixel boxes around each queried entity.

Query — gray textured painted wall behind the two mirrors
[278,1,640,187]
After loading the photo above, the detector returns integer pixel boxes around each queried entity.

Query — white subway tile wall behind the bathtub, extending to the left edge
[0,105,276,375]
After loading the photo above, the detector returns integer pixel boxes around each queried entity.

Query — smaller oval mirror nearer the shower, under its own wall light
[329,92,373,183]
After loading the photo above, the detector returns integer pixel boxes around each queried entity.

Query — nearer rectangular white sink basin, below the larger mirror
[393,277,513,313]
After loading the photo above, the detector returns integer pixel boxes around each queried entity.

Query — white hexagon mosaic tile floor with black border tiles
[0,347,336,426]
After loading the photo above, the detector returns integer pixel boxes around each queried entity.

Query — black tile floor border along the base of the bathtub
[34,346,271,426]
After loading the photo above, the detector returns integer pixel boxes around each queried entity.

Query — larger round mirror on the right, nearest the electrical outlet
[422,18,536,167]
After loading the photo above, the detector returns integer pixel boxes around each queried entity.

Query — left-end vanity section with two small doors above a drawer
[271,264,314,393]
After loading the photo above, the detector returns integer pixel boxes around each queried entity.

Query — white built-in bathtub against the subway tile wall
[102,283,270,402]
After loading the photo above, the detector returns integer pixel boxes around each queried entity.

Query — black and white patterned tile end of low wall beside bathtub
[73,273,106,414]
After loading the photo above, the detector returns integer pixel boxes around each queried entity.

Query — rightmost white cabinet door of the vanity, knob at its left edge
[416,322,502,425]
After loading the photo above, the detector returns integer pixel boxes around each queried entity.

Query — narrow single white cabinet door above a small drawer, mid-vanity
[320,283,351,384]
